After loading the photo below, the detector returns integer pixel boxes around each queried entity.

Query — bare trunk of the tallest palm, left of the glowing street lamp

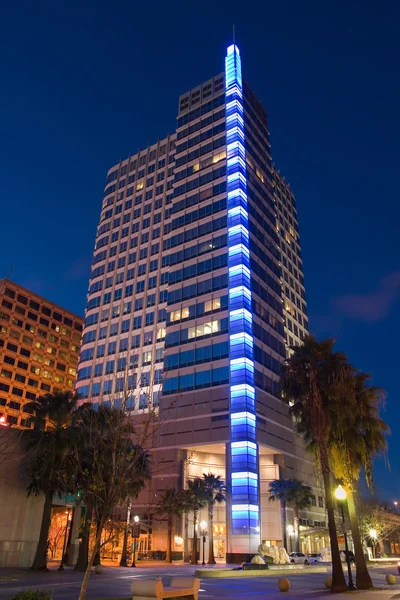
[320,445,347,593]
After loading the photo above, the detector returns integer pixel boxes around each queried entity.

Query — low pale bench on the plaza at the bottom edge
[131,577,200,600]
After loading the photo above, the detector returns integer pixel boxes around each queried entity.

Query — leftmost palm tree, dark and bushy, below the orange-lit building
[23,392,78,571]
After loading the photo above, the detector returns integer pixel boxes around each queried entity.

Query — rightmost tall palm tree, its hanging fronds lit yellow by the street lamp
[330,372,389,590]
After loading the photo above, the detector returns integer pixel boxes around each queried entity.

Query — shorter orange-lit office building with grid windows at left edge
[0,279,83,428]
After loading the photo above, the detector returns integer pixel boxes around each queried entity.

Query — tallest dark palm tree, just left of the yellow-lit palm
[281,336,351,592]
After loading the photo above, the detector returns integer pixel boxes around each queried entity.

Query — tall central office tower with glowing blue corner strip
[78,45,324,561]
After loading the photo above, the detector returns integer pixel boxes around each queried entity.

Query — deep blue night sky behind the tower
[0,0,400,500]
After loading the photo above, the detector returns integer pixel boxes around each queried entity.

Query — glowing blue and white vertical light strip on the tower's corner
[225,44,260,535]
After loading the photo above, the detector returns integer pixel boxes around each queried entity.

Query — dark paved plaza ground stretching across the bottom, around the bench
[0,564,400,600]
